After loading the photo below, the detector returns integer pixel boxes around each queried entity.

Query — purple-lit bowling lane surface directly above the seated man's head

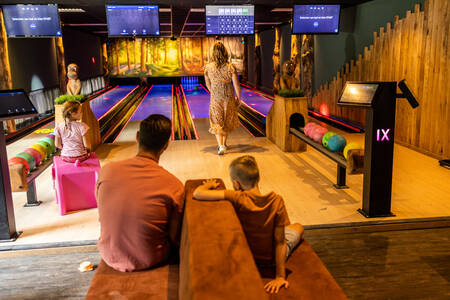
[131,84,172,121]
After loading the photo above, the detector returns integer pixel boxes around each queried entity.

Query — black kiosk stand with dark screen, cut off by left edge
[0,90,37,242]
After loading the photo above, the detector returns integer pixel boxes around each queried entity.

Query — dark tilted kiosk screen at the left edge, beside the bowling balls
[0,90,37,120]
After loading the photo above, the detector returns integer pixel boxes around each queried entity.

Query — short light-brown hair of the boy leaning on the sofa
[229,155,259,188]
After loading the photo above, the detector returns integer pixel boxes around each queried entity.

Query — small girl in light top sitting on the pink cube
[55,101,90,162]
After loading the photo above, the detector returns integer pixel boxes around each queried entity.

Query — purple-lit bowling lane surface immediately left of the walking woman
[183,85,210,119]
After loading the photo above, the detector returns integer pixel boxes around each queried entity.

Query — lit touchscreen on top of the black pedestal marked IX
[338,82,378,105]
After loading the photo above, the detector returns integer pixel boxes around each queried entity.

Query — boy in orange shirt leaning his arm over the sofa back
[194,155,304,293]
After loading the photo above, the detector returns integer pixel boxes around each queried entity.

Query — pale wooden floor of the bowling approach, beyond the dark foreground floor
[0,120,450,249]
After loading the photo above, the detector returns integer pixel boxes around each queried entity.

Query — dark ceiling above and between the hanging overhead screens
[1,0,370,37]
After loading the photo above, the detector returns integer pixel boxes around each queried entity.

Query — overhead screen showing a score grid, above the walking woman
[205,5,255,35]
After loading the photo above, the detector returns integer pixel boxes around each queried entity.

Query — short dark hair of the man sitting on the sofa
[139,114,172,153]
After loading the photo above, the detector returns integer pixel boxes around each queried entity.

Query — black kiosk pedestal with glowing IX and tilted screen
[338,80,419,218]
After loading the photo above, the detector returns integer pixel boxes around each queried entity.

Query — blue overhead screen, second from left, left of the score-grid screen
[106,5,160,36]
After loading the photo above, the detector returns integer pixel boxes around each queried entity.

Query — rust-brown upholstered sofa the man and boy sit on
[86,180,347,300]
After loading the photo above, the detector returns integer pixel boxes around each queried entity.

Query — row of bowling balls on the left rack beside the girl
[8,133,56,174]
